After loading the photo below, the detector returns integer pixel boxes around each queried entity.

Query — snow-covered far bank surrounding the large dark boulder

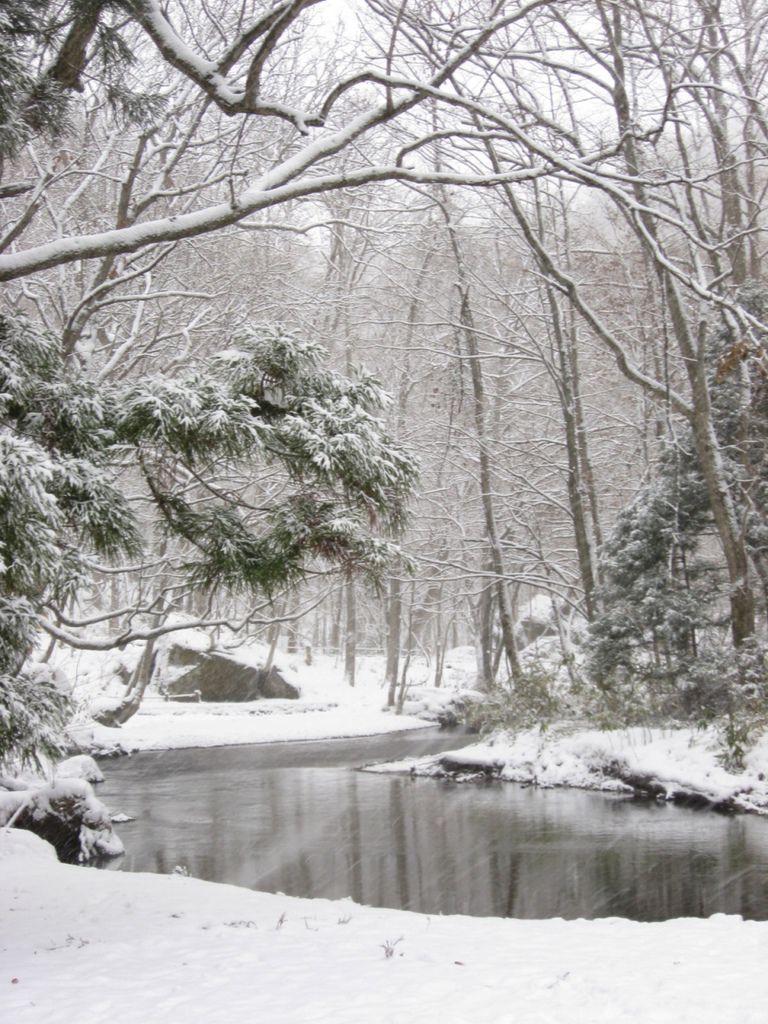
[55,630,474,753]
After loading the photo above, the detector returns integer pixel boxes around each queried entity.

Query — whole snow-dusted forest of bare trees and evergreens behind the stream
[0,0,768,753]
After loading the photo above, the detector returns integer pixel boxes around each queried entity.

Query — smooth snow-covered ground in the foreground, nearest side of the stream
[0,831,768,1024]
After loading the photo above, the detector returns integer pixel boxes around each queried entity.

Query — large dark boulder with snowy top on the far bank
[163,644,299,701]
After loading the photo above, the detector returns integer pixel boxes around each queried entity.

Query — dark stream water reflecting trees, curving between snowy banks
[98,730,768,921]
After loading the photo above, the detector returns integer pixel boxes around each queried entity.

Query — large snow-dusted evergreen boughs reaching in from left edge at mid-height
[0,315,415,764]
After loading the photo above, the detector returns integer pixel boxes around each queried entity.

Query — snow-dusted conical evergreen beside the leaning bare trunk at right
[589,287,768,719]
